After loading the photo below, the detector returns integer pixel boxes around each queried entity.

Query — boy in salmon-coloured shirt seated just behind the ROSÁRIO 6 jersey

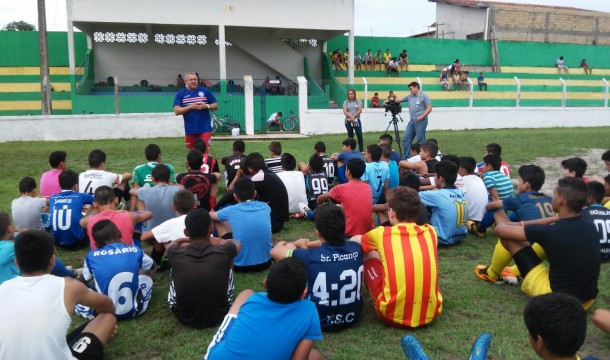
[80,185,152,250]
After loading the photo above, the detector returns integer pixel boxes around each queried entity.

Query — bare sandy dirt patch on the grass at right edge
[513,149,607,195]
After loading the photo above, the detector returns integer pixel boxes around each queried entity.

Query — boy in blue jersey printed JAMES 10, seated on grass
[49,170,95,248]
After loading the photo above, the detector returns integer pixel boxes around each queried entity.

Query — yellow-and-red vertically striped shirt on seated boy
[362,223,443,327]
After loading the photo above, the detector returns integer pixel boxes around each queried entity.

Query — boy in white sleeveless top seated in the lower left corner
[0,229,116,359]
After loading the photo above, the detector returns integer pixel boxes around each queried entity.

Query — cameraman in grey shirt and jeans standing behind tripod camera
[385,81,432,152]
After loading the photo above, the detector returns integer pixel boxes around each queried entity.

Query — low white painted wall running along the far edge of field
[0,106,610,142]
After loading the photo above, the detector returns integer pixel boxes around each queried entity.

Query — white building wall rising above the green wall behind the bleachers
[436,3,487,39]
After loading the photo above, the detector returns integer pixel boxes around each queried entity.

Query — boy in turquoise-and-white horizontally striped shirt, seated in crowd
[468,154,512,238]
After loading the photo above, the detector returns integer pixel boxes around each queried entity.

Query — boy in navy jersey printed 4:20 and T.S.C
[271,204,364,330]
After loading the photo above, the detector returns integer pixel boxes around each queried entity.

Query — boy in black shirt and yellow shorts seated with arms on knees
[495,177,600,309]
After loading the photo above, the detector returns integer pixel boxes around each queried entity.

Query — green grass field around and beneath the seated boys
[0,128,610,360]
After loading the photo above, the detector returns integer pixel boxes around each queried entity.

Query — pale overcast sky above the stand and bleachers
[0,0,610,37]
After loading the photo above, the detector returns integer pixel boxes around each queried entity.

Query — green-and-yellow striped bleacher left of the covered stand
[0,66,78,116]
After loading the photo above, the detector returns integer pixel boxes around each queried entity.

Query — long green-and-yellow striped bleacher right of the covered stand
[334,65,610,107]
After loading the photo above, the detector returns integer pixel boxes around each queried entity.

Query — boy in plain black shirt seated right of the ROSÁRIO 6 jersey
[167,209,241,328]
